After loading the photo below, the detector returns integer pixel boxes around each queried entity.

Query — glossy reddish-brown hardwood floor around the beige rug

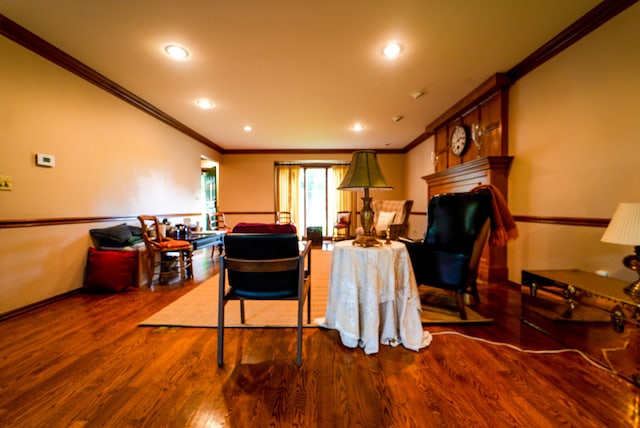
[0,249,640,427]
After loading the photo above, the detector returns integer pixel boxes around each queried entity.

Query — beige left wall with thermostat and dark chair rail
[0,38,219,313]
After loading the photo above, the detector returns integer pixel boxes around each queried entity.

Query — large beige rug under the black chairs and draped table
[139,249,491,328]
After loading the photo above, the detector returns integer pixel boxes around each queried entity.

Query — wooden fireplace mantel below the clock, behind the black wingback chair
[422,156,513,282]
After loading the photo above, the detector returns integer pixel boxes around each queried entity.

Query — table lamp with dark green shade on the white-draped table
[338,150,393,247]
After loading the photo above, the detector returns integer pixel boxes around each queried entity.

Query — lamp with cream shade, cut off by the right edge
[601,202,640,297]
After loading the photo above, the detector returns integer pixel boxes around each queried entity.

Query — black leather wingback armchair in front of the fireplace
[403,190,492,319]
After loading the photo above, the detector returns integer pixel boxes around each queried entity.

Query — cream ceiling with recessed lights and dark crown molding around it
[0,0,598,150]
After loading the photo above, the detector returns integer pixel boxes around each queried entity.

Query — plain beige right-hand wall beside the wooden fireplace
[508,4,640,281]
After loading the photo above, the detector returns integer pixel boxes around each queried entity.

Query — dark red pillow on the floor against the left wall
[82,248,138,293]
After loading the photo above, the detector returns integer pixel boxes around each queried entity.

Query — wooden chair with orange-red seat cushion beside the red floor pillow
[138,215,193,287]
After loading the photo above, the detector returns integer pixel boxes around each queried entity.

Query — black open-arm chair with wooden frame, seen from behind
[218,233,311,366]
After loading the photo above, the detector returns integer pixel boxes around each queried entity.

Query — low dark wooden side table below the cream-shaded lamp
[520,269,640,386]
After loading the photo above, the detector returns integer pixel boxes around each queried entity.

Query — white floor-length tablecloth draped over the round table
[323,241,431,354]
